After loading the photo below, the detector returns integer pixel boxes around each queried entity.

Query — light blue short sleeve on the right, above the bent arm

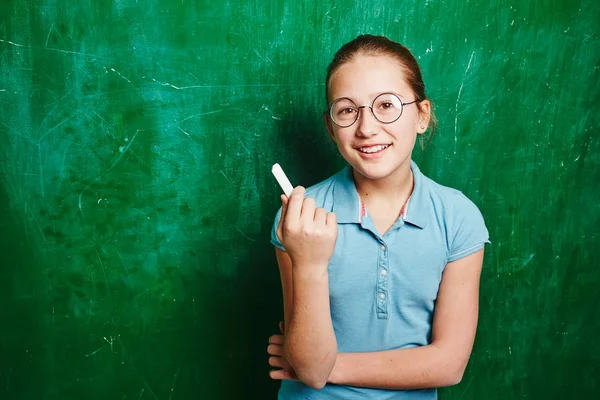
[448,193,490,262]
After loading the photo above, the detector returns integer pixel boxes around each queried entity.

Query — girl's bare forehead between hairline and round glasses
[329,55,412,102]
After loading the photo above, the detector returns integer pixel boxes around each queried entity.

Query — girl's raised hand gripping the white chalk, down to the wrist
[277,186,337,268]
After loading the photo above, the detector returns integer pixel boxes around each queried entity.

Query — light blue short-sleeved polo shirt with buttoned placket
[271,161,489,400]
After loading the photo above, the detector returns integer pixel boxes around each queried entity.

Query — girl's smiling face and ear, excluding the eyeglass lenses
[325,55,430,179]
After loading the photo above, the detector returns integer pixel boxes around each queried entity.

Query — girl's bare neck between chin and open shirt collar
[353,159,414,207]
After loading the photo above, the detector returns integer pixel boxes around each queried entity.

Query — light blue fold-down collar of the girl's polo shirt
[332,160,430,228]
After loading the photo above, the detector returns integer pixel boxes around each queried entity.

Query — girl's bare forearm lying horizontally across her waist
[329,344,468,390]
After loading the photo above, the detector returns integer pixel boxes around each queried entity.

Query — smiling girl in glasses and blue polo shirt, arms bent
[268,35,489,399]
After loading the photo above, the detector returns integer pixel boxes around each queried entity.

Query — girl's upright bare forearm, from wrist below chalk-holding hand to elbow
[285,266,337,388]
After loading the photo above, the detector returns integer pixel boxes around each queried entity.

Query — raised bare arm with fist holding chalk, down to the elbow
[276,189,337,389]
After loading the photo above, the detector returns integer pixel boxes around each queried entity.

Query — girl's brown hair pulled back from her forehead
[325,35,437,147]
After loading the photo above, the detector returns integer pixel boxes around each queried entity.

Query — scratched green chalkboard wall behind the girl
[0,0,600,400]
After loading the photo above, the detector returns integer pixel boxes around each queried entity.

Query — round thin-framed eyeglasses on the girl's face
[329,93,417,128]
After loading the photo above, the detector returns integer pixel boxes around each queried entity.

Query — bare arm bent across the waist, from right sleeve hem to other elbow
[329,249,483,389]
